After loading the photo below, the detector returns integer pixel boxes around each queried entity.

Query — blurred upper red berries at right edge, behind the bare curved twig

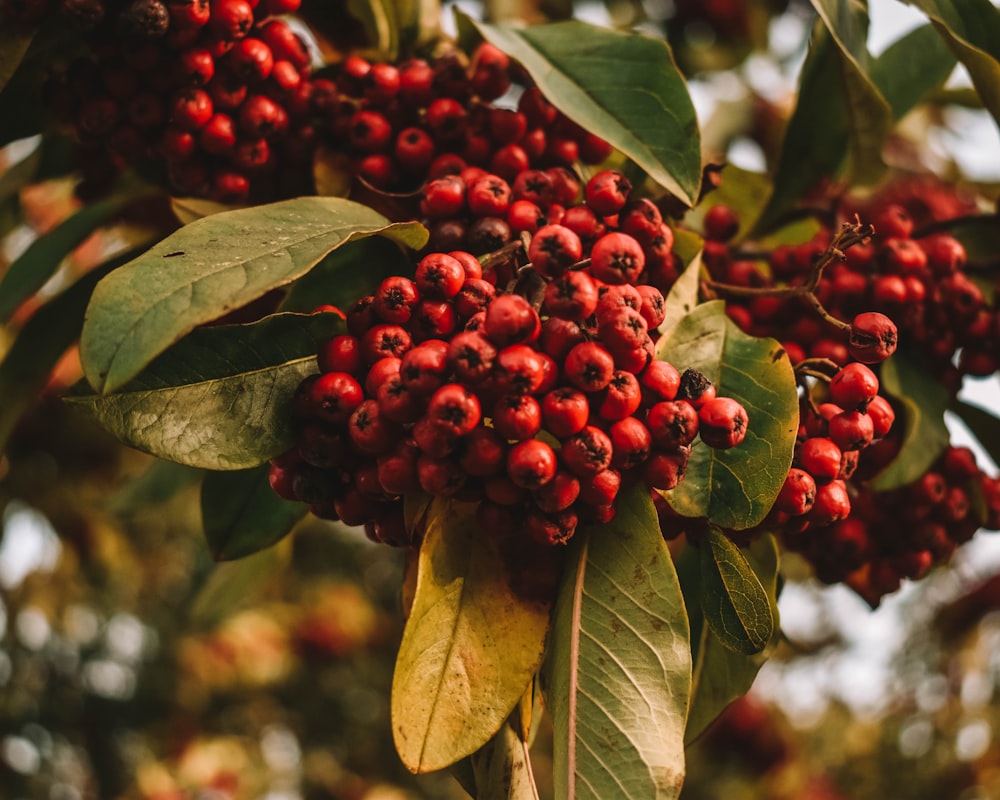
[705,203,1000,391]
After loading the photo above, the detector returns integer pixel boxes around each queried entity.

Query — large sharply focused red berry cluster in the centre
[271,171,749,544]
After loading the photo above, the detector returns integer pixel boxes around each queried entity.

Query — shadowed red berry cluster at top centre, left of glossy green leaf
[315,43,611,197]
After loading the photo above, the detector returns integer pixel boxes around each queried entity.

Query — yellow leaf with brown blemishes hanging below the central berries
[392,498,558,772]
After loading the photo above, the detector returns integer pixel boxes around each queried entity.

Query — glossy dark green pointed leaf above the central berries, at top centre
[466,18,701,205]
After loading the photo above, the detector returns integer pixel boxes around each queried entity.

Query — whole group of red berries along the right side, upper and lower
[696,197,1000,604]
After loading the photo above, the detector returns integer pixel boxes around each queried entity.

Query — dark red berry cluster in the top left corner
[22,0,314,202]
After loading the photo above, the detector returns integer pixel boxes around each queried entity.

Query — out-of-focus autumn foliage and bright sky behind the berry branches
[0,0,1000,800]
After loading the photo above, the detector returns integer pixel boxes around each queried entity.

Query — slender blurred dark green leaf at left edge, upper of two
[0,194,134,322]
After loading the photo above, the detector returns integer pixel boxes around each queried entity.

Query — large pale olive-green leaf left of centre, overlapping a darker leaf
[80,197,427,393]
